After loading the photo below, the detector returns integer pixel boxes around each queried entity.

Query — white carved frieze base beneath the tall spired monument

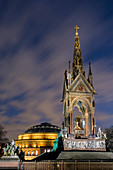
[64,138,106,151]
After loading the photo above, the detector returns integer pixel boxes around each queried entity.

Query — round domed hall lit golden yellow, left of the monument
[15,122,61,160]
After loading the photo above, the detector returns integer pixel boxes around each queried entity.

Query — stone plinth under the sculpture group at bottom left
[0,156,20,169]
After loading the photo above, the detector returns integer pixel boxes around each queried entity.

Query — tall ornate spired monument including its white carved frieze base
[62,26,105,150]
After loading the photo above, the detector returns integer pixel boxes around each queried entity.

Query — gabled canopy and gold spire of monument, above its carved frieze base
[62,27,95,137]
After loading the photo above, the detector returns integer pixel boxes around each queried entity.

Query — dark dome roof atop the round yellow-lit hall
[25,122,61,133]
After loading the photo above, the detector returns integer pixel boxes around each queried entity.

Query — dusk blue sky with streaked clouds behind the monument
[0,0,113,139]
